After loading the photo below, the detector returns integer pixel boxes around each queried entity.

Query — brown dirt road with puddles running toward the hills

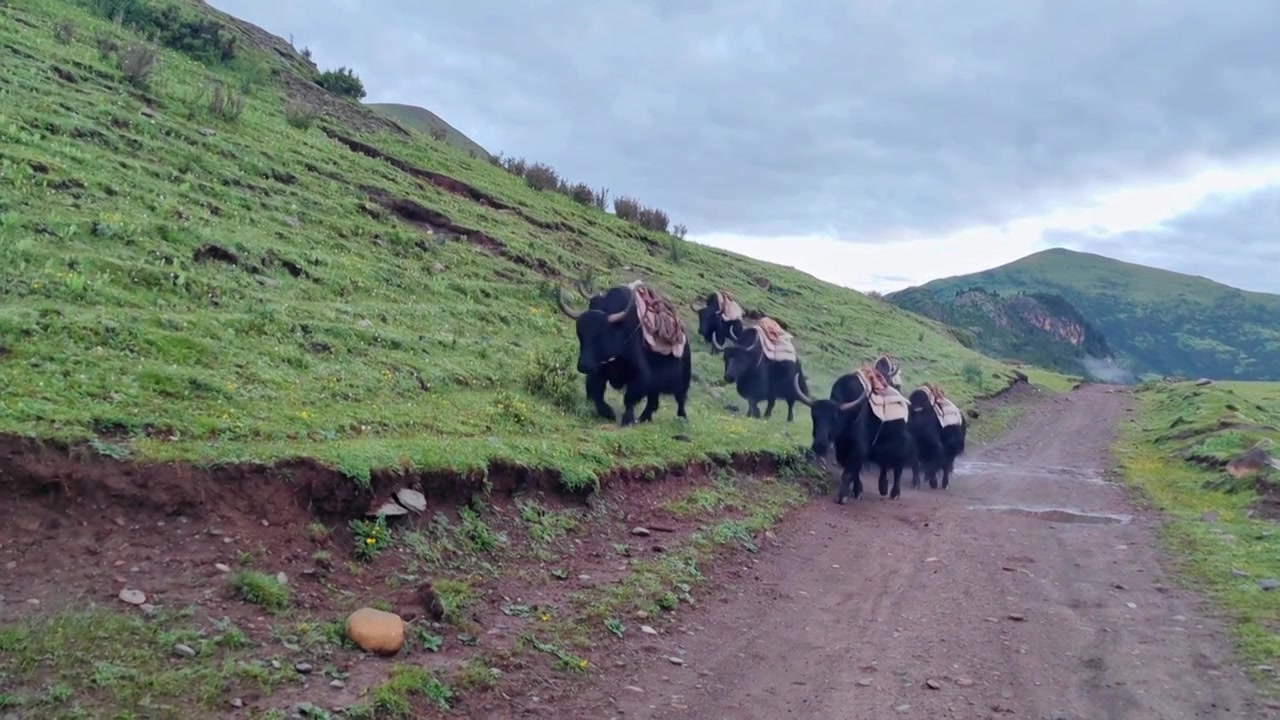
[564,386,1274,720]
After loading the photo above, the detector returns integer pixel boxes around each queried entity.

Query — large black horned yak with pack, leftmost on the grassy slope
[556,281,694,427]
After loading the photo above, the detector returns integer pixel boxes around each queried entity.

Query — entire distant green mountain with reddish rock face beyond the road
[886,249,1280,380]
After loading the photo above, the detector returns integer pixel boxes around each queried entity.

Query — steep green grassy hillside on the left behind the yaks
[0,0,1010,487]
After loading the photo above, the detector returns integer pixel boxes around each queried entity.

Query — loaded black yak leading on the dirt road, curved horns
[795,366,914,505]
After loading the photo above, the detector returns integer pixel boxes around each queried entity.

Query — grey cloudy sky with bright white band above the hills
[210,0,1280,292]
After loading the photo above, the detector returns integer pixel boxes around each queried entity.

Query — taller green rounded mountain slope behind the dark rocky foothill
[890,249,1280,380]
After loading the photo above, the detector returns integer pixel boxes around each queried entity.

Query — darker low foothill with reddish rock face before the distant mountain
[892,287,1112,374]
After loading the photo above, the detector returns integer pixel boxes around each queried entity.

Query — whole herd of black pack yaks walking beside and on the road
[557,281,966,503]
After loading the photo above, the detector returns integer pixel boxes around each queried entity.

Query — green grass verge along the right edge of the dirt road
[1119,383,1280,683]
